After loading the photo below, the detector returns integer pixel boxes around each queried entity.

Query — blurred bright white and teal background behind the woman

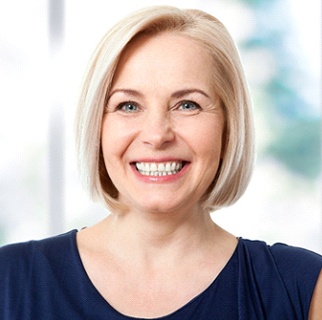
[0,0,322,253]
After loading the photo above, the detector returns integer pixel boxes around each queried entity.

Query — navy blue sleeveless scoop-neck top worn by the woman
[0,230,322,320]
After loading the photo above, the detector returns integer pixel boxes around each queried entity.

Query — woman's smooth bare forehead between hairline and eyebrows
[113,32,214,89]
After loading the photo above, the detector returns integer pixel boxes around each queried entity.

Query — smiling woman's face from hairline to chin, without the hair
[102,33,224,212]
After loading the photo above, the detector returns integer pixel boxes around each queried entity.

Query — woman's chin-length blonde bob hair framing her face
[76,6,254,212]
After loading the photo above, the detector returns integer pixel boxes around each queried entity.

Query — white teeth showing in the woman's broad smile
[135,162,183,177]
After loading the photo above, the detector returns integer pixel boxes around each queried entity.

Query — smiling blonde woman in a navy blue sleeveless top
[0,7,322,320]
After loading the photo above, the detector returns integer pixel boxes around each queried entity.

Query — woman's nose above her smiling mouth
[140,110,175,149]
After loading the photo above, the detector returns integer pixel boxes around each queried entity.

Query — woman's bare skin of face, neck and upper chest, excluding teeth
[77,33,237,318]
